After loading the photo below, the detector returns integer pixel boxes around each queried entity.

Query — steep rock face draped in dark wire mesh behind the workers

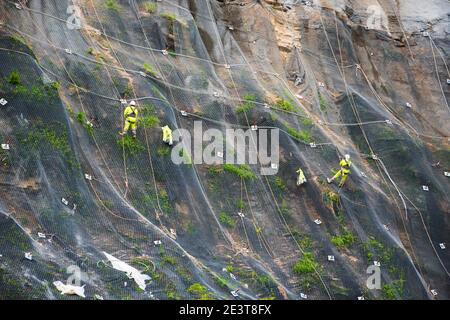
[0,0,450,299]
